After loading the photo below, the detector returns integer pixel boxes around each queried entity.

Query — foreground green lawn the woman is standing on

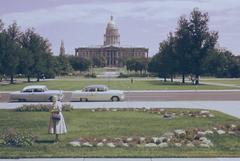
[0,109,240,158]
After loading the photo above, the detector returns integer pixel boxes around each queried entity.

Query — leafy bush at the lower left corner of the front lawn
[1,128,37,146]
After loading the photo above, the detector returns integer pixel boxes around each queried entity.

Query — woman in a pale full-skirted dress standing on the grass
[48,96,67,142]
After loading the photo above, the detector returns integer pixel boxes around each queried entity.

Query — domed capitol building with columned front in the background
[75,16,148,67]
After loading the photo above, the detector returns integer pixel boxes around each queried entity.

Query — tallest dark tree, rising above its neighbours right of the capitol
[189,9,218,84]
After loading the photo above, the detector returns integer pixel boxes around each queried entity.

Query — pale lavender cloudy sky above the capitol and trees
[0,0,240,56]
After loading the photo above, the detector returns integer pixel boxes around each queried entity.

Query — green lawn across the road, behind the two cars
[0,79,233,91]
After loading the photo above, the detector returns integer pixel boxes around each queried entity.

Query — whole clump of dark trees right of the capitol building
[148,8,240,84]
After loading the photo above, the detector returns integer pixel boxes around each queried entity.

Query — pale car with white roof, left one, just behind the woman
[10,85,64,102]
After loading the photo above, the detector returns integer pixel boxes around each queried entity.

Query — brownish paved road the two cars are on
[0,90,240,102]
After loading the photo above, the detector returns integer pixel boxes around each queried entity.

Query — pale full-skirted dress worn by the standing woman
[48,101,67,134]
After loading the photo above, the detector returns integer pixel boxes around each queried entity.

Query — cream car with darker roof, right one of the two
[71,85,125,102]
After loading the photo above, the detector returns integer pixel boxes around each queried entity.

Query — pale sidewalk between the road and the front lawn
[0,101,240,118]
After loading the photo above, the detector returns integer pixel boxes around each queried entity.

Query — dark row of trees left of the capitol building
[0,19,94,83]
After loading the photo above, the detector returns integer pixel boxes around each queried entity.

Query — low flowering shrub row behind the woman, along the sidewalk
[16,104,73,112]
